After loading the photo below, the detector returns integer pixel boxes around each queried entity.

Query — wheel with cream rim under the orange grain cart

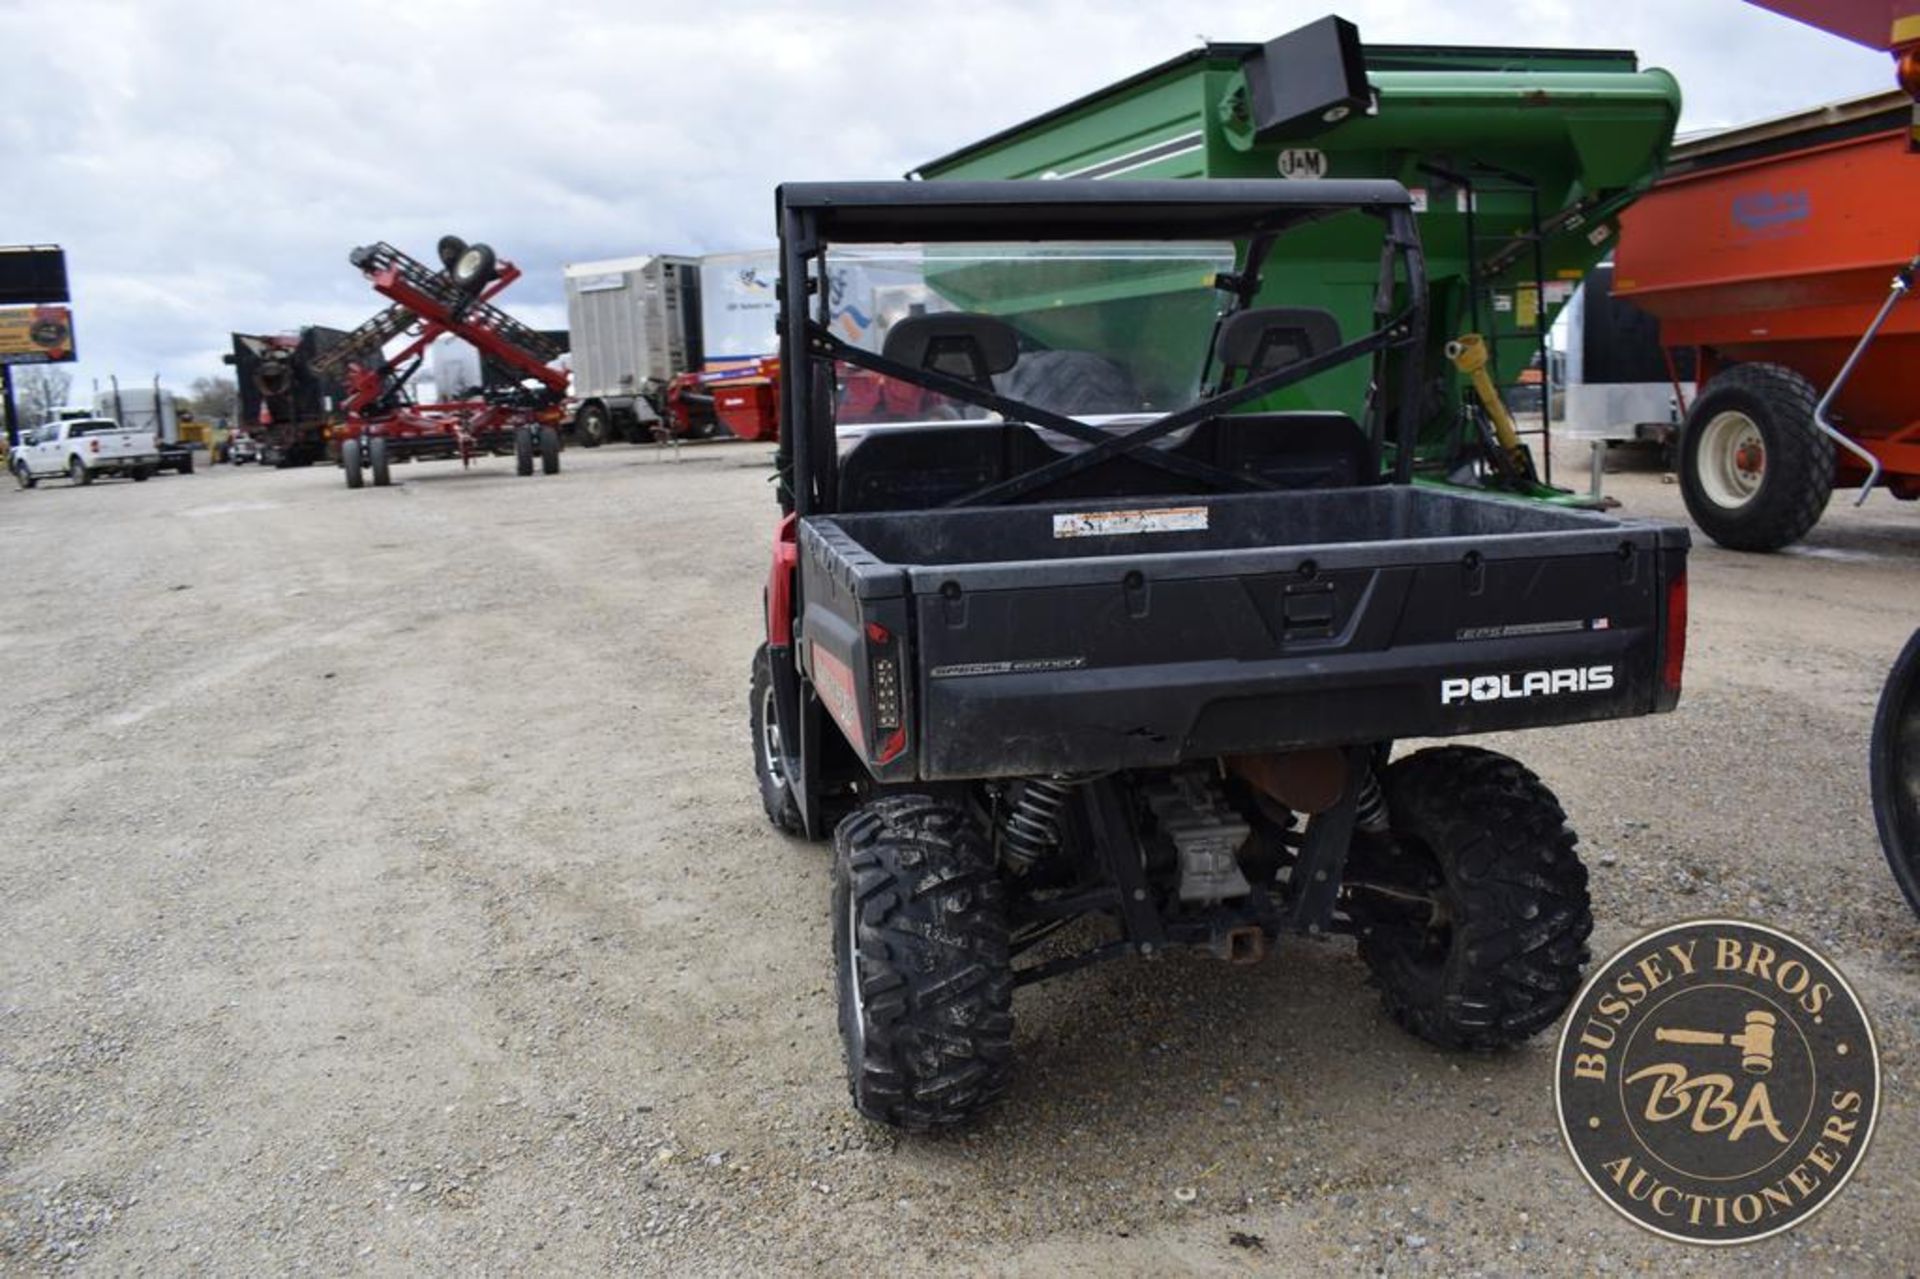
[1680,365,1834,551]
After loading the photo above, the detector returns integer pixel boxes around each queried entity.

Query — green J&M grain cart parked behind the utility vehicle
[908,17,1680,501]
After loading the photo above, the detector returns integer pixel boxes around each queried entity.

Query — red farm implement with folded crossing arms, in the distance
[317,236,566,488]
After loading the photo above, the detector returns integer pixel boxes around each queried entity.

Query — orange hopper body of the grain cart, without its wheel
[1613,131,1920,492]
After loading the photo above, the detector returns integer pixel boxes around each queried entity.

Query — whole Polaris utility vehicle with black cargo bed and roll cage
[751,181,1688,1129]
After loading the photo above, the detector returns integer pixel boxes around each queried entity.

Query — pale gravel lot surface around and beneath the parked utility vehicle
[0,435,1920,1279]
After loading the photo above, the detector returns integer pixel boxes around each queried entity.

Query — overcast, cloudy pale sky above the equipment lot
[0,0,1893,392]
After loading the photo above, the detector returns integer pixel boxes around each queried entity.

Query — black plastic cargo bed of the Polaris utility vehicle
[801,486,1686,780]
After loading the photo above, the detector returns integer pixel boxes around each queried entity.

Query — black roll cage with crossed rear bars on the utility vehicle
[774,181,1427,517]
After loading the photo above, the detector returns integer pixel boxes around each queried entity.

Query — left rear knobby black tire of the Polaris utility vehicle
[833,795,1014,1131]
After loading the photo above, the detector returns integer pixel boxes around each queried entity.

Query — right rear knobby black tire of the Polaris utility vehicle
[1359,747,1594,1052]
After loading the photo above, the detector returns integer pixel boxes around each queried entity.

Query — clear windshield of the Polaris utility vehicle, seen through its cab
[826,240,1235,434]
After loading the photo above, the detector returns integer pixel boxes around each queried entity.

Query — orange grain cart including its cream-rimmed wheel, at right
[1613,92,1920,549]
